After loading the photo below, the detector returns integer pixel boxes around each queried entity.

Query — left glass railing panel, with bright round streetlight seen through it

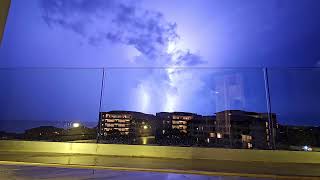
[0,69,102,142]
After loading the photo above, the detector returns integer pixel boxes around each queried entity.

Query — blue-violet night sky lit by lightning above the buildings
[0,0,320,129]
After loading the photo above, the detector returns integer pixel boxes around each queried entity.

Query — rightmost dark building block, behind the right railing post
[216,110,277,149]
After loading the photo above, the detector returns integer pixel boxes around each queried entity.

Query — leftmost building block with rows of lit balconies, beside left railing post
[100,111,154,143]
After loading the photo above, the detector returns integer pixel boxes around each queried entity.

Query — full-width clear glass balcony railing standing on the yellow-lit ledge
[0,68,320,151]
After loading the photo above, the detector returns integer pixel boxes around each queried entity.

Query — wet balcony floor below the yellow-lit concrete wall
[0,152,320,179]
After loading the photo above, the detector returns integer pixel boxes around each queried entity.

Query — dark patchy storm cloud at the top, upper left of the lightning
[40,0,178,58]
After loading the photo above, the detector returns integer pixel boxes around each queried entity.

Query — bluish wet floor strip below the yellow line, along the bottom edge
[0,165,267,180]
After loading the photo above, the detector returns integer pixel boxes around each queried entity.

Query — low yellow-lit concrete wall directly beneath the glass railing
[0,141,320,163]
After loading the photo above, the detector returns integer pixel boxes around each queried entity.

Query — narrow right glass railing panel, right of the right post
[269,68,320,151]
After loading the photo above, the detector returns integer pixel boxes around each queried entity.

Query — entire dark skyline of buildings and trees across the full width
[0,110,320,150]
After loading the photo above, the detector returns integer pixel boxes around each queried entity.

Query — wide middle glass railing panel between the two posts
[99,68,271,149]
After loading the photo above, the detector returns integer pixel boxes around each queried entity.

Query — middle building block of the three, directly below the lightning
[156,112,216,145]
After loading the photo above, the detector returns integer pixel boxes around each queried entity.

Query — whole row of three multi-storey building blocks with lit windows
[100,110,277,149]
